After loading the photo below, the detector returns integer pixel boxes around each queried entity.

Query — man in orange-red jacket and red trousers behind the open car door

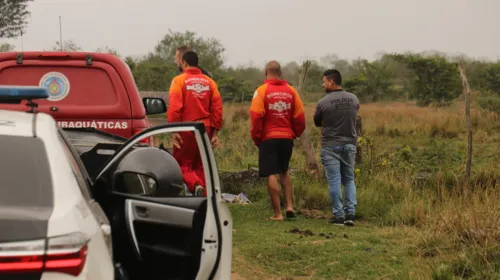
[167,51,222,196]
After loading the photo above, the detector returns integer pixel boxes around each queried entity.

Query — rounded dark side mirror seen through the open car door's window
[112,147,184,197]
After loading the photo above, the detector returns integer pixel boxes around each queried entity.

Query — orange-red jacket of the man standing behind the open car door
[167,67,222,130]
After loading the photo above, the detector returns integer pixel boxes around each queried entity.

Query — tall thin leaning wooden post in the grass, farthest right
[458,62,472,193]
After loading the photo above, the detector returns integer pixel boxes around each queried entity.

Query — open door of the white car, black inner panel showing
[94,123,232,279]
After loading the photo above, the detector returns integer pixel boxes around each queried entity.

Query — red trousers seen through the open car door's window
[173,127,212,196]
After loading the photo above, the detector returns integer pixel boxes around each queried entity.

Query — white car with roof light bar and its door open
[0,86,232,280]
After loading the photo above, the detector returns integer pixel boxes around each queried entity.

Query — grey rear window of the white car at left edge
[0,135,53,207]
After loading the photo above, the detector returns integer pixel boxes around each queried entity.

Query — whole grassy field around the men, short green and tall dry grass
[215,99,500,279]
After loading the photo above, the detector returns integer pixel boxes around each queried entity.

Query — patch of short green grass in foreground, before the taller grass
[231,202,434,279]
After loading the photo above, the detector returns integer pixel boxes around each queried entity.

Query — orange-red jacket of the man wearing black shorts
[250,79,306,145]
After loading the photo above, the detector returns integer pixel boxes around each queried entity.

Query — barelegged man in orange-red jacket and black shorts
[250,61,306,221]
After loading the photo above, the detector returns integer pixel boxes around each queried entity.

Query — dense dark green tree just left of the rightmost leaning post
[389,53,462,106]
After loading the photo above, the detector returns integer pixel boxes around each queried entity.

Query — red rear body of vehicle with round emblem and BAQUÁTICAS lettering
[0,52,149,138]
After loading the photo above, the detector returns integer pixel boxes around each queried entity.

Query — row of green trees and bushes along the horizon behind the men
[0,30,500,113]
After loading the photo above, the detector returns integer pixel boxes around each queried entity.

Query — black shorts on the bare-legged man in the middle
[259,139,293,177]
